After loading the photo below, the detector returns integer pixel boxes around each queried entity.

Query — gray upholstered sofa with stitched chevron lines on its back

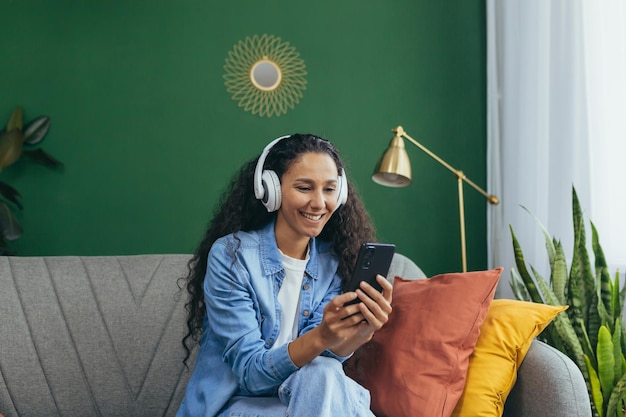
[0,255,591,417]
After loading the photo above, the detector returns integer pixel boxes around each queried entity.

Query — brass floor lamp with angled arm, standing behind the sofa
[372,126,500,272]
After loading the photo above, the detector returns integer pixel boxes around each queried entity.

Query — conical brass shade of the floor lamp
[372,135,411,187]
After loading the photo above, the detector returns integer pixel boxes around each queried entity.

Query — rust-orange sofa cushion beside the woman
[346,268,502,417]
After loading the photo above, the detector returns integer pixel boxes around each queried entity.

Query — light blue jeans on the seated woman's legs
[218,356,374,417]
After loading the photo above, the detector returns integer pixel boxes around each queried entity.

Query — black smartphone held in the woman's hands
[345,243,396,304]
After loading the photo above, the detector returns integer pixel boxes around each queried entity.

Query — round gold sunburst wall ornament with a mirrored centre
[224,34,307,117]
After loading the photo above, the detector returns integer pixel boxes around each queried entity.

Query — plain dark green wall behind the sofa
[0,0,487,274]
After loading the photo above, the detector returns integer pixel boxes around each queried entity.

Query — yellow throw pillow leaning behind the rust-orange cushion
[452,299,568,417]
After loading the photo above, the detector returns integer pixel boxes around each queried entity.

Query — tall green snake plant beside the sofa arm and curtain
[510,187,626,417]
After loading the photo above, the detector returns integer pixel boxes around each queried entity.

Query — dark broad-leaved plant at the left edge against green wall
[0,106,63,255]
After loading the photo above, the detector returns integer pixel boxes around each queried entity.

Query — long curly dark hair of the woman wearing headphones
[181,134,375,365]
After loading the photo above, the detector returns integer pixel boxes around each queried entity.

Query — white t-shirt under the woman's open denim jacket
[274,250,309,346]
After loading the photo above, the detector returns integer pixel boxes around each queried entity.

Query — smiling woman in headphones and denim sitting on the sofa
[177,134,392,417]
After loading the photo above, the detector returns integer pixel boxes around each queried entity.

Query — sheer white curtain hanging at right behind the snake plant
[487,0,626,298]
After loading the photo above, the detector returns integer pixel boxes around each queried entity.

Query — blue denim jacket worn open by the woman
[177,221,346,417]
